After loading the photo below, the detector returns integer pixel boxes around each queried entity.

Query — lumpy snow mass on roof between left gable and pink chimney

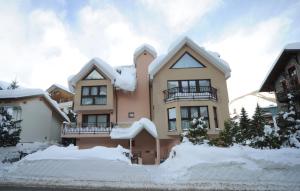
[115,66,136,91]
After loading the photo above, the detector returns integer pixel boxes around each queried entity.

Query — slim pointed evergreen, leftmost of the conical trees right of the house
[236,107,252,145]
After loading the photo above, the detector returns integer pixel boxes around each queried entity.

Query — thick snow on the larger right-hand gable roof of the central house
[148,37,231,79]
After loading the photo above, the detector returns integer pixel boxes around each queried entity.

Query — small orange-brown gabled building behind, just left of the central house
[47,84,74,114]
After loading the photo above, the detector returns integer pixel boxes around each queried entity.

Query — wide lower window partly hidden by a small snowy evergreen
[180,106,209,130]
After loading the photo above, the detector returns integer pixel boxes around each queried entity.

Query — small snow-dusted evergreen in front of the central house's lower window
[184,117,207,145]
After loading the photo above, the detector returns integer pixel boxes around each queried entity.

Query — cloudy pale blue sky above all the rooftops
[0,0,300,99]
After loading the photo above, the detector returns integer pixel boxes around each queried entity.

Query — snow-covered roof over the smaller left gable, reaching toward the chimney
[69,58,136,92]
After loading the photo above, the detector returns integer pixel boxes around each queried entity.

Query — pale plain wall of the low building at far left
[0,97,62,142]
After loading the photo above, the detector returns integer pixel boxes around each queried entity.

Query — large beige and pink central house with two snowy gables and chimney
[62,37,231,164]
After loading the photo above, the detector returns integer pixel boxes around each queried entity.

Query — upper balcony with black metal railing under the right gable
[163,86,218,102]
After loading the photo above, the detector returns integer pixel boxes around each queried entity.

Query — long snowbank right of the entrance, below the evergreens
[161,141,300,172]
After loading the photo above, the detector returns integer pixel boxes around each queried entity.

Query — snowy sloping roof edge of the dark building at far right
[259,42,300,91]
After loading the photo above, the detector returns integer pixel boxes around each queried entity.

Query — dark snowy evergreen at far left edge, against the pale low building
[0,107,21,147]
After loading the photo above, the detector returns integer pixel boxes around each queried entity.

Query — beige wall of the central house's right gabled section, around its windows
[152,46,229,139]
